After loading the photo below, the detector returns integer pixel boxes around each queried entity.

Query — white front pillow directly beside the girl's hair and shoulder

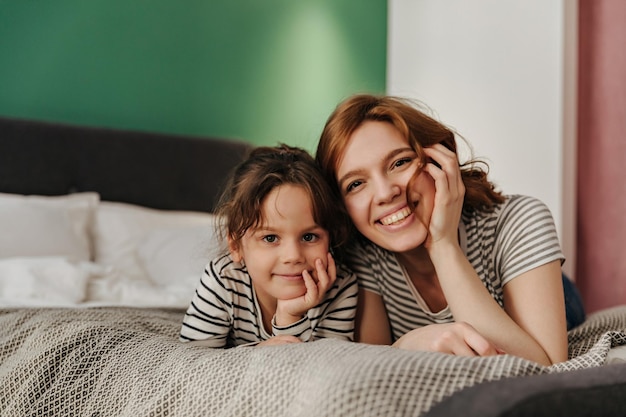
[138,221,226,288]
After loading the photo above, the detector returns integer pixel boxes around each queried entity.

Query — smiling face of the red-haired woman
[337,121,435,252]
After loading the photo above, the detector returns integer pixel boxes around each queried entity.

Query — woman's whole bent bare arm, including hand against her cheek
[425,145,567,365]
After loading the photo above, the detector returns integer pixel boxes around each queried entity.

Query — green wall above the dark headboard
[0,0,387,150]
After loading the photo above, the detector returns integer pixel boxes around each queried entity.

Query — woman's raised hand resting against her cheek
[424,144,465,248]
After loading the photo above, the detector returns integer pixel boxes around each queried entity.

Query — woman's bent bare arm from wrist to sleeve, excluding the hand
[431,240,567,365]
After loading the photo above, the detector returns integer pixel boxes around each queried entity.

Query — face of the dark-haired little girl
[230,184,329,306]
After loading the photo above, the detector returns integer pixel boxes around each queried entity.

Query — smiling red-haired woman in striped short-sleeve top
[316,95,567,365]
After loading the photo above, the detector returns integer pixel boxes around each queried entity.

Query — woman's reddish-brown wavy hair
[315,94,504,210]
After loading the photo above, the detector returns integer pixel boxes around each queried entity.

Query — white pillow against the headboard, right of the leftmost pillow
[93,201,221,283]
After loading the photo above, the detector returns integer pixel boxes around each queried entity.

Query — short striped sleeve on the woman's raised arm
[495,196,565,285]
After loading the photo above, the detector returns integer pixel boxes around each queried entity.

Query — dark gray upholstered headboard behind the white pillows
[0,117,252,211]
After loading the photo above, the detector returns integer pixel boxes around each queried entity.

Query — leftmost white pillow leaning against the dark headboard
[0,193,99,261]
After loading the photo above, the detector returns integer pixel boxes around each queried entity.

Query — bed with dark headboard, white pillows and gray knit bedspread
[0,117,626,417]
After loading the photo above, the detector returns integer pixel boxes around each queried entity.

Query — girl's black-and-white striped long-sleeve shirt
[180,254,358,347]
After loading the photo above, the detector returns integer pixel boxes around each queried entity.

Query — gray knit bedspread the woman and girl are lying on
[0,306,626,417]
